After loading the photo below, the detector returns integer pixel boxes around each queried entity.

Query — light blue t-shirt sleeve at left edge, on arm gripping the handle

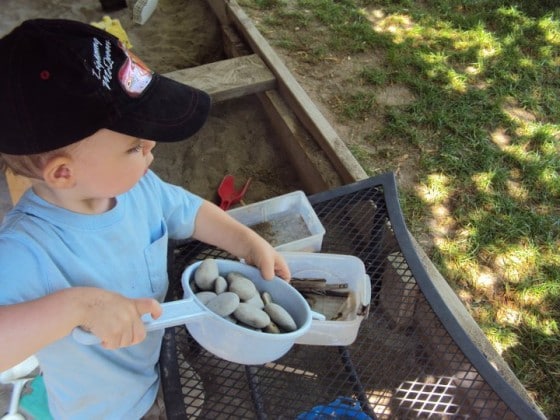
[0,238,52,305]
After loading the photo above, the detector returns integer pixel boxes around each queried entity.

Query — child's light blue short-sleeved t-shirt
[0,171,202,419]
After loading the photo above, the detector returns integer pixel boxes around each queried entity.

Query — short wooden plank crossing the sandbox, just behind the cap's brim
[165,54,276,102]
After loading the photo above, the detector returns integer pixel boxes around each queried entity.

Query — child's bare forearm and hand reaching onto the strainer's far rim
[193,201,290,280]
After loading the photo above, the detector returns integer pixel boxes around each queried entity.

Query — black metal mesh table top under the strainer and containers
[160,174,544,419]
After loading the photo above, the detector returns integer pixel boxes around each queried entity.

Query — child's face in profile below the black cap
[72,129,156,199]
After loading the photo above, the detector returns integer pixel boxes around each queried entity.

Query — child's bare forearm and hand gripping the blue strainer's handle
[0,287,161,371]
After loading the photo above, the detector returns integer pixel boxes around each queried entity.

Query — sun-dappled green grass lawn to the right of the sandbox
[328,0,560,417]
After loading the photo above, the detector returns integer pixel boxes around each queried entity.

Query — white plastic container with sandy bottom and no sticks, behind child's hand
[228,191,325,252]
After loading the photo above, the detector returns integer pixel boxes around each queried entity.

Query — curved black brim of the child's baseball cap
[107,74,212,142]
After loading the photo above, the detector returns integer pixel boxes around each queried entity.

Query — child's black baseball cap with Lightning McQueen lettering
[0,19,211,155]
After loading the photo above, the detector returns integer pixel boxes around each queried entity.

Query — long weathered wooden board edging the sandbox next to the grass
[218,0,367,183]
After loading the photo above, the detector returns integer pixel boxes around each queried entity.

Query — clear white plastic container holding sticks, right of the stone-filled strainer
[282,252,371,346]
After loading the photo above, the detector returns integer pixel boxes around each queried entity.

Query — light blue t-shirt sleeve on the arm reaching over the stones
[143,171,204,239]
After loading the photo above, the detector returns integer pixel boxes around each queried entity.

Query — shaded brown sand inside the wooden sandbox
[0,0,301,203]
